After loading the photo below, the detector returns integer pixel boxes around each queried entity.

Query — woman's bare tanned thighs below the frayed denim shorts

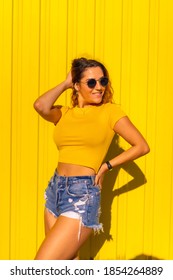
[35,211,92,260]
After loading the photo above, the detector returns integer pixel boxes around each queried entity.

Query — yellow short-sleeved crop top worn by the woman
[54,103,125,172]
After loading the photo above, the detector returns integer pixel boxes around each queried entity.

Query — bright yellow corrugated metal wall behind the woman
[0,0,173,259]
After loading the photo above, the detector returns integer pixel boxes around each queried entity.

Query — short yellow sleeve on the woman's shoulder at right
[108,103,127,129]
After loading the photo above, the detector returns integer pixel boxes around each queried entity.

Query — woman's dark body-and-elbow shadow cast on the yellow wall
[80,135,146,260]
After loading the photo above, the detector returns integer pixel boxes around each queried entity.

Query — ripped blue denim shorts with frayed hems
[45,171,102,232]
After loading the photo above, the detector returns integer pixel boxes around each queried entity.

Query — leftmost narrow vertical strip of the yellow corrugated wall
[0,1,12,259]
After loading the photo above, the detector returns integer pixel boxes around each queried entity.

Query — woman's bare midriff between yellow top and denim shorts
[57,162,96,176]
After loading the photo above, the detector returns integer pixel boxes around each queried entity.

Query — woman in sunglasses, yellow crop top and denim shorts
[34,58,149,260]
